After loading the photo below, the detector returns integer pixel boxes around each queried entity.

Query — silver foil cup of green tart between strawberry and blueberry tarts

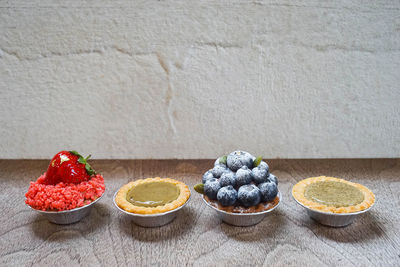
[113,191,192,227]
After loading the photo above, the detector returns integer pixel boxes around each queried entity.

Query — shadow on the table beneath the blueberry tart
[221,210,286,242]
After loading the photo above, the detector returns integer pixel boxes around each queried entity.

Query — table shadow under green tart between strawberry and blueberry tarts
[119,206,195,242]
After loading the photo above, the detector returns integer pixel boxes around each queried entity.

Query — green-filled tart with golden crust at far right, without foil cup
[292,176,375,213]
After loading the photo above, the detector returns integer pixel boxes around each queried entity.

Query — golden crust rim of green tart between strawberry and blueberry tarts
[115,177,190,214]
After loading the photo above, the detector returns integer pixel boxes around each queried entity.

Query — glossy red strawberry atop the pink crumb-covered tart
[44,151,96,185]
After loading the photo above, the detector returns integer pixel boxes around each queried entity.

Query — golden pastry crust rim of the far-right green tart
[292,176,375,213]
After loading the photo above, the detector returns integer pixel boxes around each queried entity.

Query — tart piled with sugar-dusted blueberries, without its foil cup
[194,150,279,213]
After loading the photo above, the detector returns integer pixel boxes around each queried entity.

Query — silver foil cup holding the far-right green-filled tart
[293,197,375,227]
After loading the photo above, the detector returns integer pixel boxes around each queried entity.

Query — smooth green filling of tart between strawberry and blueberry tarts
[126,182,180,207]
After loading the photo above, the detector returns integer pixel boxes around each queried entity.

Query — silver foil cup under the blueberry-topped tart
[202,191,282,226]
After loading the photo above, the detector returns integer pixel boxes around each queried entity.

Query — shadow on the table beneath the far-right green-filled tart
[310,212,385,243]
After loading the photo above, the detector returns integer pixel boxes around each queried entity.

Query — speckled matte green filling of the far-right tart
[304,181,364,208]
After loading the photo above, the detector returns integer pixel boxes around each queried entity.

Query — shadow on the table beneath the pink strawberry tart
[31,203,110,242]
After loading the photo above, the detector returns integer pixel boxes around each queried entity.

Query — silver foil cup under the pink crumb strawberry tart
[27,193,104,224]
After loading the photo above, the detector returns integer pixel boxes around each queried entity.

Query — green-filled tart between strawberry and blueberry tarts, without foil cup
[115,177,190,214]
